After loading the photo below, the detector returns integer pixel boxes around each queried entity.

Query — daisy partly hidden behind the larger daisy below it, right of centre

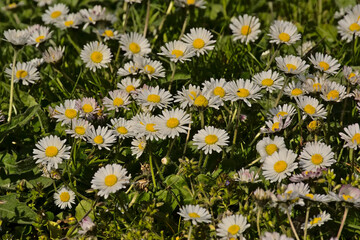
[256,136,286,162]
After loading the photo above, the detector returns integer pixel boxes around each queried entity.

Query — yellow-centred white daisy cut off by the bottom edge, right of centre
[216,215,250,239]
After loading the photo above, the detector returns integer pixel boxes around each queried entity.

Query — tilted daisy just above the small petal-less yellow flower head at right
[295,96,327,119]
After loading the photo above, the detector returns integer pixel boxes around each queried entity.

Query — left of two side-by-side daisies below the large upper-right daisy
[275,55,309,74]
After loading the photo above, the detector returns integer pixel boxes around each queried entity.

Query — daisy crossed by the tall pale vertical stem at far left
[5,62,40,86]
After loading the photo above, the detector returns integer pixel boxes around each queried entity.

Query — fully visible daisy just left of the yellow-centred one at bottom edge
[178,205,211,225]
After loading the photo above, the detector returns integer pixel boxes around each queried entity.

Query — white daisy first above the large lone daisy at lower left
[86,126,116,151]
